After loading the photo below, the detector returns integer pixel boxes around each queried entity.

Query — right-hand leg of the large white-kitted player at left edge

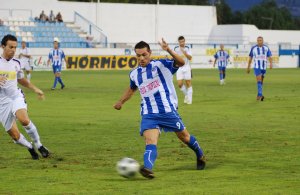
[16,108,50,158]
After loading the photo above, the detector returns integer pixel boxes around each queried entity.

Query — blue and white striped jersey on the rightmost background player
[249,45,272,70]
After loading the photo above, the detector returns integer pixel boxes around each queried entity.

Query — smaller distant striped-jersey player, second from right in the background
[213,44,230,85]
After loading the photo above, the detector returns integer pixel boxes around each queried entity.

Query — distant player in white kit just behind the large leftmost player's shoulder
[19,40,32,81]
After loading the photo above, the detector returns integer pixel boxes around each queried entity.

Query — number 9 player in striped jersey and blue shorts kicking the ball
[114,39,205,179]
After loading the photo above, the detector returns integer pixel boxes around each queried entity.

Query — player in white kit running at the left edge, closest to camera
[0,35,49,159]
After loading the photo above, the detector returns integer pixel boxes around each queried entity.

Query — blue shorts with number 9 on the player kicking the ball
[140,111,185,136]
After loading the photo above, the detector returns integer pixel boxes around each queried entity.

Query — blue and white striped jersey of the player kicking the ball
[129,59,178,115]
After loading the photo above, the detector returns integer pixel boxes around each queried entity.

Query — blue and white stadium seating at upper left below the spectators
[0,17,91,48]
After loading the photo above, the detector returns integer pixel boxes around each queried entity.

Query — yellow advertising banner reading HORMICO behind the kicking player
[66,55,168,70]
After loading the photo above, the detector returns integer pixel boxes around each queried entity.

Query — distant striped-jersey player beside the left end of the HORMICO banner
[48,37,68,90]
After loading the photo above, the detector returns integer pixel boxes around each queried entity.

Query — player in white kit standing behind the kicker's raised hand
[174,36,193,104]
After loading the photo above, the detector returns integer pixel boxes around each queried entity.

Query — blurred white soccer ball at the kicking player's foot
[117,157,140,178]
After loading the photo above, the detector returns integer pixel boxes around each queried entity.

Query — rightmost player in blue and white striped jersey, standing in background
[247,36,273,101]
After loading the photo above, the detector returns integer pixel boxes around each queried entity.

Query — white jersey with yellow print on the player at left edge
[0,57,24,106]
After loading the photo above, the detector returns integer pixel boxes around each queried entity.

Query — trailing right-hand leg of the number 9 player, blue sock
[175,129,205,170]
